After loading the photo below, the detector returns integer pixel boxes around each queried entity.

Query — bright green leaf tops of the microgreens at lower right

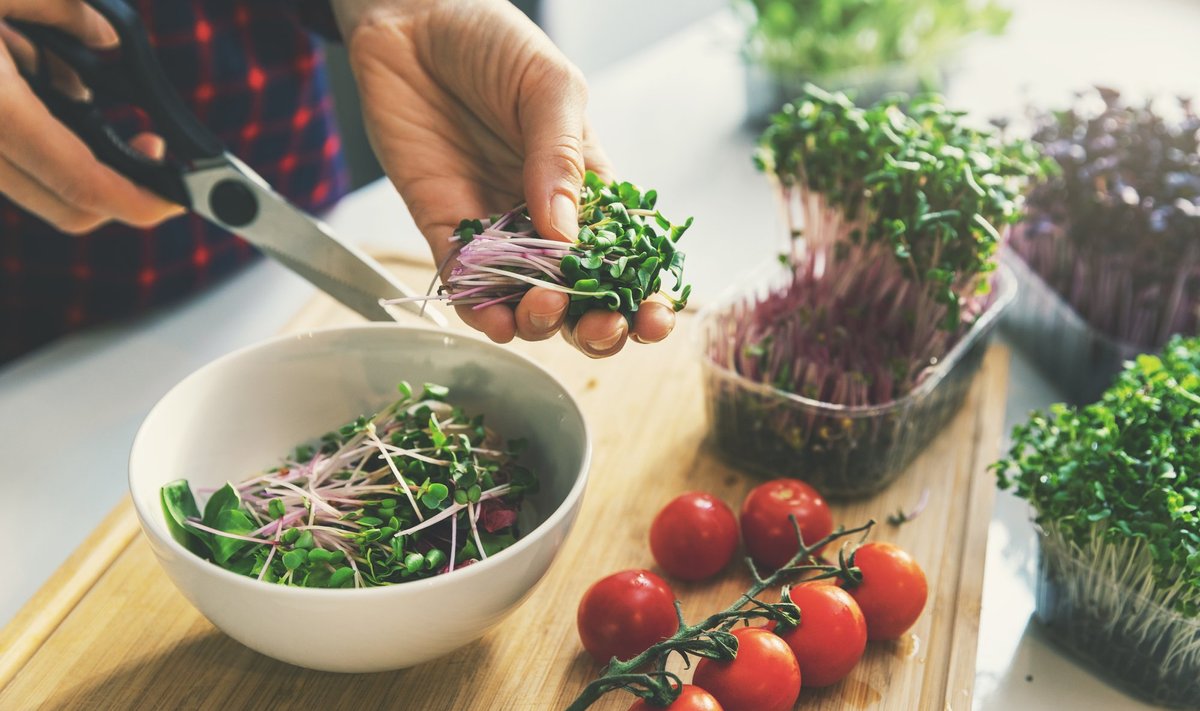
[994,336,1200,616]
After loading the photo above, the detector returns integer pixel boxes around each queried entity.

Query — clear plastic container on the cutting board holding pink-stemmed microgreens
[701,265,1016,498]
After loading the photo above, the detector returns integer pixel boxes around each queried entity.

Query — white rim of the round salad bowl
[126,322,593,599]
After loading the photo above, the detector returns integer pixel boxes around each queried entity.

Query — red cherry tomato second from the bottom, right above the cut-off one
[692,627,800,711]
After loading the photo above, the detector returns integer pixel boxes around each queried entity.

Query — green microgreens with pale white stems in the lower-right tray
[994,337,1200,701]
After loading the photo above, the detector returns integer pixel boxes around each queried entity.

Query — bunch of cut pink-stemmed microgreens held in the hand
[384,171,691,321]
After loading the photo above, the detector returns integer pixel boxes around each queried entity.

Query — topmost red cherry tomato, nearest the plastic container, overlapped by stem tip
[742,479,833,569]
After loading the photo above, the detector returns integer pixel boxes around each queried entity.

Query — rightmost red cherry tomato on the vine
[846,542,929,639]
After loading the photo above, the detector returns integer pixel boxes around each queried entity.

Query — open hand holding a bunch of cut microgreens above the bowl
[333,0,674,357]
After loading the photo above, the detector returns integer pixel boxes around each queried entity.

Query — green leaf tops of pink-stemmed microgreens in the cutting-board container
[756,84,1044,330]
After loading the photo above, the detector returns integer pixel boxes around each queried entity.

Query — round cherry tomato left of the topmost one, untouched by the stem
[650,491,738,580]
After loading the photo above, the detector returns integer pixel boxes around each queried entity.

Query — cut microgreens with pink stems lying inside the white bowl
[162,382,538,587]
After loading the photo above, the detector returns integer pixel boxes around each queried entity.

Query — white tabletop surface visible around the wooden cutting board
[0,0,1200,711]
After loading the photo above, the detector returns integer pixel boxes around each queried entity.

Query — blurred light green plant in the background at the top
[737,0,1010,121]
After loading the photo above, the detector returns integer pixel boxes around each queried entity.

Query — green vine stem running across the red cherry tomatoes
[566,515,875,711]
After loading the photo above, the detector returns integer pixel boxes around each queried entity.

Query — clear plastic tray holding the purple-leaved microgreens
[1002,252,1146,405]
